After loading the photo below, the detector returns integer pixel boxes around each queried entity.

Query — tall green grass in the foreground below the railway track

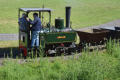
[0,40,120,80]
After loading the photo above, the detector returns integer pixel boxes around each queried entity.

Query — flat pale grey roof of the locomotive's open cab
[19,8,52,12]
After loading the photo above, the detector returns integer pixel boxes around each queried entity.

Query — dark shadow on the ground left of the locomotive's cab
[0,47,19,58]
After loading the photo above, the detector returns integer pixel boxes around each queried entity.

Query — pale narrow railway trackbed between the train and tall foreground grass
[0,45,106,66]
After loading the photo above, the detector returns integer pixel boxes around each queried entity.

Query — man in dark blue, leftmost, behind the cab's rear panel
[18,13,29,31]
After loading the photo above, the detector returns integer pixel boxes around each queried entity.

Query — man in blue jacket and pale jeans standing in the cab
[29,13,42,48]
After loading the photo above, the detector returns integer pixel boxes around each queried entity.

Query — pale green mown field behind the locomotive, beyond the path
[0,0,120,33]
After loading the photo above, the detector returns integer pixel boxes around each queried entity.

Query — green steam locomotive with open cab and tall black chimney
[18,7,76,56]
